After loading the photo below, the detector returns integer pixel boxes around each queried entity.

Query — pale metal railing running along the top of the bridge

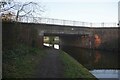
[11,16,118,27]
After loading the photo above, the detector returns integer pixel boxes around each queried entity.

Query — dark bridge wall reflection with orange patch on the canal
[63,47,119,70]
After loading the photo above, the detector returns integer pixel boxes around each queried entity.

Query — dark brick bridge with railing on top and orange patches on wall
[3,17,118,51]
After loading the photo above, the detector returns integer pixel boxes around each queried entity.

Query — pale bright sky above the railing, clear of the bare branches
[16,0,119,23]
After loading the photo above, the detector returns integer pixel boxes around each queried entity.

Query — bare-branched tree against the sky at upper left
[0,0,44,21]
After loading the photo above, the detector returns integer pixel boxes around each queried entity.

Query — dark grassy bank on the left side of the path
[2,44,45,78]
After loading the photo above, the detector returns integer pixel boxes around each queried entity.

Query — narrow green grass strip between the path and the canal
[60,51,96,80]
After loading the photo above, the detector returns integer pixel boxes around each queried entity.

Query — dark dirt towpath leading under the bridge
[34,49,63,78]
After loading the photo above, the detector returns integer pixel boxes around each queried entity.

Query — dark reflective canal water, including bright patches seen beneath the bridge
[44,44,120,80]
